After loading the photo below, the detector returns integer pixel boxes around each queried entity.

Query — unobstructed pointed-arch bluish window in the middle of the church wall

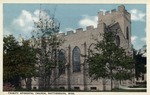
[72,46,80,72]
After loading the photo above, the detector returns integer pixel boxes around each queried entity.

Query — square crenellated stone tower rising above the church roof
[98,5,132,51]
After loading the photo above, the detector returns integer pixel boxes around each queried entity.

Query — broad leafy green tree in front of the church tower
[87,31,133,90]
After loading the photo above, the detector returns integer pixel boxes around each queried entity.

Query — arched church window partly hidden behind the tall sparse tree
[58,49,66,74]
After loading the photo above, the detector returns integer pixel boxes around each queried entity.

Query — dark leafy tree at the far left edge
[3,35,19,86]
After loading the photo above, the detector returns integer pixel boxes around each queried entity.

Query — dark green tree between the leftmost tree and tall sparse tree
[18,40,38,89]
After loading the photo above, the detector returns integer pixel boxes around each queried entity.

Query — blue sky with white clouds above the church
[3,3,146,50]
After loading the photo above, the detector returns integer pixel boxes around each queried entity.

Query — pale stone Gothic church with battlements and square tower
[22,5,133,91]
